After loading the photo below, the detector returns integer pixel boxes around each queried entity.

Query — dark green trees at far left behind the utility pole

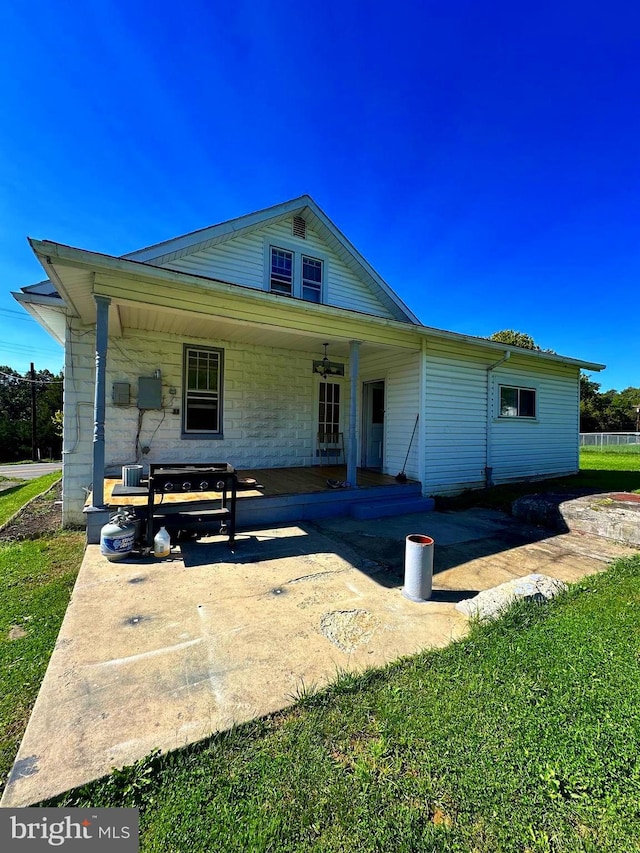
[0,365,62,462]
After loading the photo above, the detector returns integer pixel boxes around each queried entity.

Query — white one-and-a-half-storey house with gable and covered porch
[14,195,603,536]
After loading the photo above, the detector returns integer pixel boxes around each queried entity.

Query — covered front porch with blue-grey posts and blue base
[25,244,425,541]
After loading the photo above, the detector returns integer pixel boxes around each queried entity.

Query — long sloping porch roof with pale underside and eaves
[14,240,605,371]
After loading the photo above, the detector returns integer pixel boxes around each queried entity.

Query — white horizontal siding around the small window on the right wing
[425,342,579,494]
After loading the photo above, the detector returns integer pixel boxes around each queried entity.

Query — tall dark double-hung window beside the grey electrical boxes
[182,344,224,438]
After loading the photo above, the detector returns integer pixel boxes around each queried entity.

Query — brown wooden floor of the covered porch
[105,465,416,507]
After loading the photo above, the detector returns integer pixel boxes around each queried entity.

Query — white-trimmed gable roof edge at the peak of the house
[121,195,420,325]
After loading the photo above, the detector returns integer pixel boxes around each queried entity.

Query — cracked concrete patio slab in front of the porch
[1,511,631,806]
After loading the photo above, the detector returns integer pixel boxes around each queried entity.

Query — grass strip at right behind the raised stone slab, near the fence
[436,446,640,512]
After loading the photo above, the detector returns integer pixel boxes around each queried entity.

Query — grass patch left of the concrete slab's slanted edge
[0,532,85,780]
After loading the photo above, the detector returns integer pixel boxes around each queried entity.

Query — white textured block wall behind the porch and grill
[63,327,348,524]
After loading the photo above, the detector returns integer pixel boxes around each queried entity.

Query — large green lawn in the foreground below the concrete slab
[46,555,640,853]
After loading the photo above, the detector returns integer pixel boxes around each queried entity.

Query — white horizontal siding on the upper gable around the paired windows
[155,220,404,319]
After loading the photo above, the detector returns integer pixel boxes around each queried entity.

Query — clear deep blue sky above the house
[0,0,640,390]
